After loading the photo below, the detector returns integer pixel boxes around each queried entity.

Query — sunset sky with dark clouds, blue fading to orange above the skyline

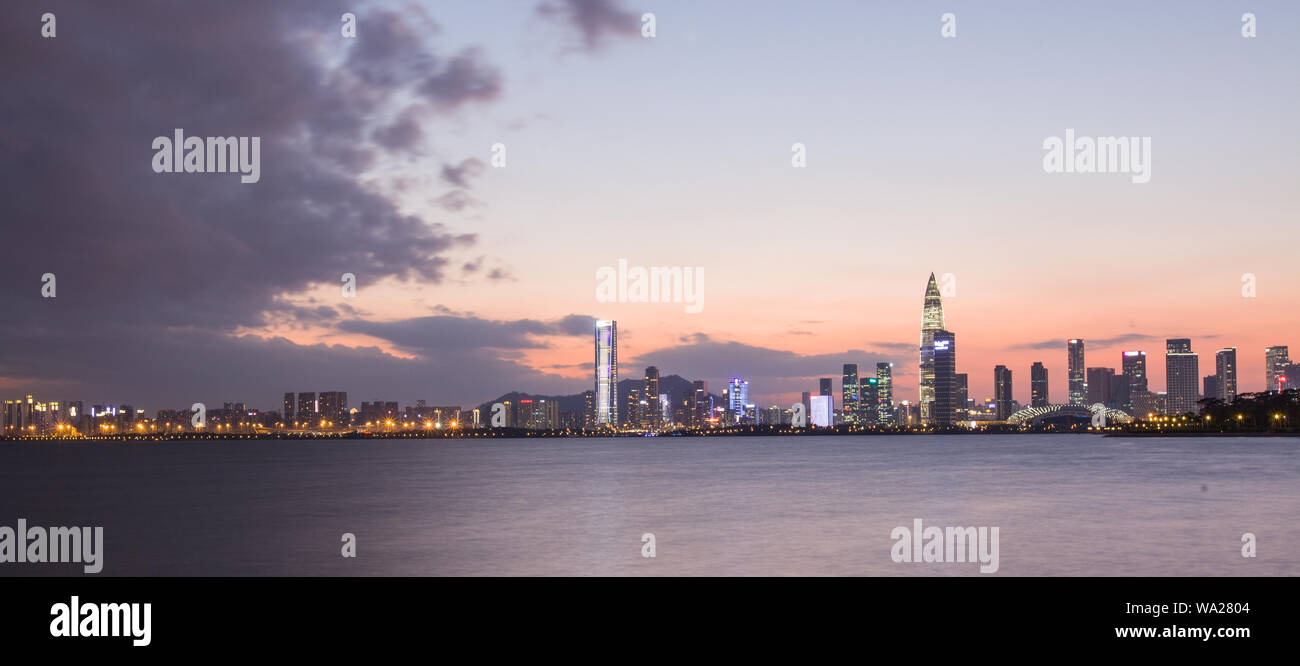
[0,0,1300,411]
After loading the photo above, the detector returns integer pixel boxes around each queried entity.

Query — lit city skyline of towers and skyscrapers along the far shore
[5,273,1290,425]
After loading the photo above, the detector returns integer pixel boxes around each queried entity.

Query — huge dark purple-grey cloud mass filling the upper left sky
[0,0,501,401]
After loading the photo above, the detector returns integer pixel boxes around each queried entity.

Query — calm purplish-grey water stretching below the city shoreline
[0,436,1300,575]
